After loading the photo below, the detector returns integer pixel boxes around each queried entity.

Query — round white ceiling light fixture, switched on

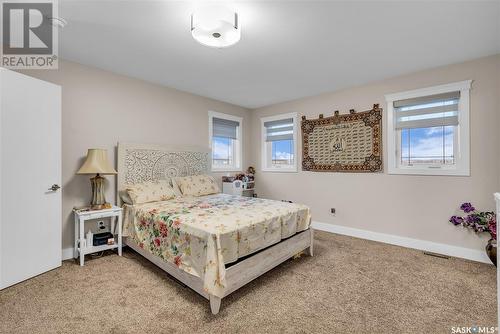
[191,7,241,48]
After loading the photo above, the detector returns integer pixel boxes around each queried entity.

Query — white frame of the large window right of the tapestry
[385,80,472,176]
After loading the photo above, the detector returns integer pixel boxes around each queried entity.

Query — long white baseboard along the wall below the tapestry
[312,221,491,264]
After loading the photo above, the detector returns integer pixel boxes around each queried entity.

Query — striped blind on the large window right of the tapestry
[394,91,460,129]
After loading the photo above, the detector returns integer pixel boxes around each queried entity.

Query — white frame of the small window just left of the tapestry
[260,113,298,173]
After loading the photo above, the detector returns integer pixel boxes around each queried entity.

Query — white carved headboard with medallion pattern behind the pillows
[116,143,211,206]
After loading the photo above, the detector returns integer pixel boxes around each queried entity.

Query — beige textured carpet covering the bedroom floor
[0,232,497,334]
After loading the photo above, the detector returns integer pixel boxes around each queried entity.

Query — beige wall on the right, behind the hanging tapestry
[251,55,500,249]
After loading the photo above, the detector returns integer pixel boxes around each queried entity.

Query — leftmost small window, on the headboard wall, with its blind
[208,111,242,171]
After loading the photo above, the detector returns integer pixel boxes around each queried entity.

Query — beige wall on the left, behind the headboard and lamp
[24,61,250,248]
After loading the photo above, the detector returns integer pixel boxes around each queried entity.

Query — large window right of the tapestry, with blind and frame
[386,81,471,175]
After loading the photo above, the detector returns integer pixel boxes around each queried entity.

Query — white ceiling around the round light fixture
[60,0,500,108]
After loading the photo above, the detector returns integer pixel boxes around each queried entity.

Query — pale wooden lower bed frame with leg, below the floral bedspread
[125,228,314,314]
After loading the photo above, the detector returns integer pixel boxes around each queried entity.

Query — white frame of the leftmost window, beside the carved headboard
[208,110,243,172]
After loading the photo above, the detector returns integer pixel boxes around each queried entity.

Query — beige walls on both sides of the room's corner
[18,55,500,253]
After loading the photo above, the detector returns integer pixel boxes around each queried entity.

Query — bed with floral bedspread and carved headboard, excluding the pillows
[117,143,313,314]
